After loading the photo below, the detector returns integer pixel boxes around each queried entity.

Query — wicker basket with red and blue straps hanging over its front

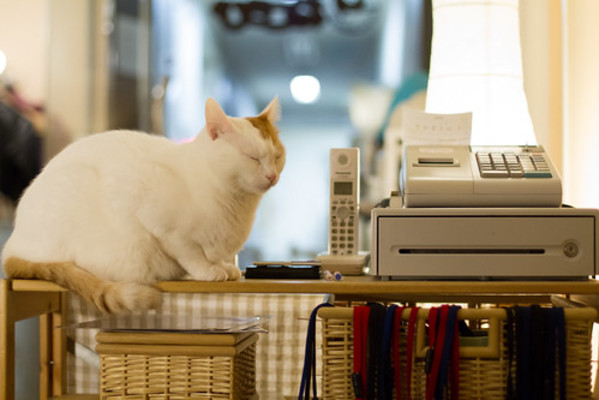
[318,307,596,400]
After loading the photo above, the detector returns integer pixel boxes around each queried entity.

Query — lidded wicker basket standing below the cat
[96,332,258,400]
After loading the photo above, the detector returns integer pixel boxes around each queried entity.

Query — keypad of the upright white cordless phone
[330,200,358,255]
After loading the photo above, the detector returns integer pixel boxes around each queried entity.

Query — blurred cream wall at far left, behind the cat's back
[0,0,99,161]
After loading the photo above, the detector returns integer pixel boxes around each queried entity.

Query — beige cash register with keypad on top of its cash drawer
[371,146,599,280]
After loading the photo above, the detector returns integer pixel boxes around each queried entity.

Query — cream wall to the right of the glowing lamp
[520,0,599,207]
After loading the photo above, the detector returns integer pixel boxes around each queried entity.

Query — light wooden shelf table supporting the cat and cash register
[0,276,599,400]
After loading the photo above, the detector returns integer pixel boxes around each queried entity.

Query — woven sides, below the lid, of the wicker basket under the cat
[100,332,256,400]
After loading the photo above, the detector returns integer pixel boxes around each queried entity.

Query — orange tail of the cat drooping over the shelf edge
[4,257,161,314]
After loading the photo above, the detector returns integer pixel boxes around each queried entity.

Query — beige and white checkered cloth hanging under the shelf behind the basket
[67,293,323,398]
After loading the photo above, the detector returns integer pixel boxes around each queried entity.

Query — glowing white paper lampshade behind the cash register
[426,0,537,145]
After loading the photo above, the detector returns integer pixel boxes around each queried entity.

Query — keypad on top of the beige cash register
[476,151,552,178]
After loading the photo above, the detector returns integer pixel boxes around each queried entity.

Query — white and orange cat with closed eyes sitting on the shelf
[2,98,285,313]
